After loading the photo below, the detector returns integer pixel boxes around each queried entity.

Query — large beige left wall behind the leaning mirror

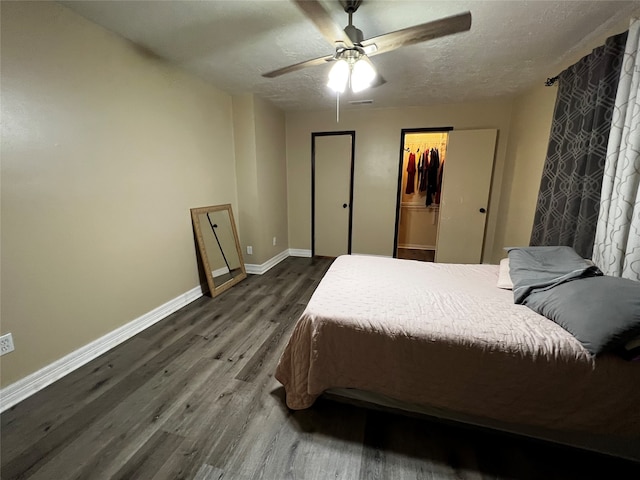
[1,2,237,386]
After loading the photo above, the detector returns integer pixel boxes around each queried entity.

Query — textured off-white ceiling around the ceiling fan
[60,0,640,111]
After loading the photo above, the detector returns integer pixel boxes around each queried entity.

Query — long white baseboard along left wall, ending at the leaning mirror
[0,286,202,412]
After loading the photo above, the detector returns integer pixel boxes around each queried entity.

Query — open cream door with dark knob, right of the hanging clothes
[436,129,498,263]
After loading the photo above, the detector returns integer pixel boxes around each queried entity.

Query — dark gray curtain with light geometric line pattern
[531,32,627,258]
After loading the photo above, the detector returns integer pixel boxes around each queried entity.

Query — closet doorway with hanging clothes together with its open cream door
[393,128,498,264]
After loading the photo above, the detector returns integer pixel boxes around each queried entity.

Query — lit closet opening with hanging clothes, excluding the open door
[394,127,452,262]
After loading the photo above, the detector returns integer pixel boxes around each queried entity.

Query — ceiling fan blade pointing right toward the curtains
[362,12,471,56]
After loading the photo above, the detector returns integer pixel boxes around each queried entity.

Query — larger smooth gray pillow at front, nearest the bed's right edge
[524,276,640,355]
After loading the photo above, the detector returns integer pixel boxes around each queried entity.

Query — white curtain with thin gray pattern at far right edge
[593,19,640,280]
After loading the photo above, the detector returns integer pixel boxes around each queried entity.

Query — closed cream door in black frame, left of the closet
[313,133,353,257]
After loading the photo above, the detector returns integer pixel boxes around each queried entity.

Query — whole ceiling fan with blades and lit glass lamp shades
[262,0,471,92]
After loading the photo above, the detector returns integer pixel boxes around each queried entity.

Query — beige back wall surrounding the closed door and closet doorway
[287,99,511,262]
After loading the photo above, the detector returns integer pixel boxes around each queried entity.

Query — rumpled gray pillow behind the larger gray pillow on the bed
[506,247,602,304]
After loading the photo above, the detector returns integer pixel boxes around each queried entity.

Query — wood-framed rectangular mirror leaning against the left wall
[191,203,247,297]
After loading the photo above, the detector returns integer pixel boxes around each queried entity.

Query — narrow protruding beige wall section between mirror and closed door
[233,94,289,265]
